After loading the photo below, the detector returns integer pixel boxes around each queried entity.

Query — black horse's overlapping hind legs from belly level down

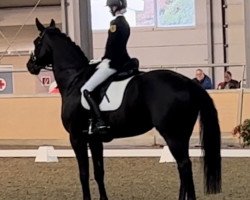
[160,135,196,200]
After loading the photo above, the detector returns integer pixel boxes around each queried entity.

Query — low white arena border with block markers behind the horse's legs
[0,146,250,163]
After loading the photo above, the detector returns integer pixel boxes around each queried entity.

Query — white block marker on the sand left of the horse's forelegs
[35,146,58,162]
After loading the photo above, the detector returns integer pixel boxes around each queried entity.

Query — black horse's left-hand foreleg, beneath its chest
[70,135,91,200]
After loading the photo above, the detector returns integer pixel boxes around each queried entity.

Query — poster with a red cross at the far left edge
[0,65,13,95]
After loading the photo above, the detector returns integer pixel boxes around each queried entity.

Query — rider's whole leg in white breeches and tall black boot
[81,61,116,133]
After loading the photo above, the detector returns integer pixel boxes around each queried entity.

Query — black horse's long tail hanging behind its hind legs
[196,85,221,194]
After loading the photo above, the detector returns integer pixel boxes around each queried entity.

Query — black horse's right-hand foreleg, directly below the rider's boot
[89,141,108,200]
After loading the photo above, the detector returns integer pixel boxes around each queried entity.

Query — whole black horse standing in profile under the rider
[27,19,221,200]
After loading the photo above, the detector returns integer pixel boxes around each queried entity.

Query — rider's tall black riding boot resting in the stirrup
[83,90,109,134]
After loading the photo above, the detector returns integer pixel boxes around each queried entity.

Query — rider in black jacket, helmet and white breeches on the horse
[81,0,131,134]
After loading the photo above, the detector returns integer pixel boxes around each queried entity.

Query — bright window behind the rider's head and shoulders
[91,0,195,30]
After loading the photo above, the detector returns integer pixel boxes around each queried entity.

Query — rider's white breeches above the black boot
[81,60,116,93]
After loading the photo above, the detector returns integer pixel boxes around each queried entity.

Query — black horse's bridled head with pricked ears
[27,18,56,75]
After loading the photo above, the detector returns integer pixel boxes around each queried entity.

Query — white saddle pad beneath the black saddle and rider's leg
[81,76,133,111]
